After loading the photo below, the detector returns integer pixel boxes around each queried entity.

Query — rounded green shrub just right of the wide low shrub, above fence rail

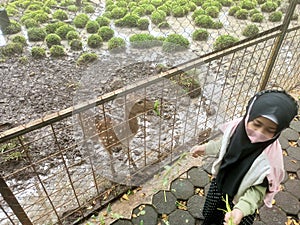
[162,34,190,52]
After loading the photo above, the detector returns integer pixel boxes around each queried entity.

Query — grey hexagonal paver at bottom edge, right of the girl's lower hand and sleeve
[259,206,286,225]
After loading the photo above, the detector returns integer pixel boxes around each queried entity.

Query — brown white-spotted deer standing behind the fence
[78,98,154,175]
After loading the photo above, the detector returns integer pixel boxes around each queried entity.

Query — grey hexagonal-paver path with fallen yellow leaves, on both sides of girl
[111,121,300,225]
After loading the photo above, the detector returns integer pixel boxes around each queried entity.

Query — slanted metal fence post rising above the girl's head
[259,0,297,91]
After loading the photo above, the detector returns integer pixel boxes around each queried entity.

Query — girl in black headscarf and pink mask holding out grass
[191,90,298,225]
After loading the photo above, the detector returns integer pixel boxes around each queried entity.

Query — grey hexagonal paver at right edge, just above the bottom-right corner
[275,191,300,215]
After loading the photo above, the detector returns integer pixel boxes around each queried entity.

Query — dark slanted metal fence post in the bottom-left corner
[0,176,33,225]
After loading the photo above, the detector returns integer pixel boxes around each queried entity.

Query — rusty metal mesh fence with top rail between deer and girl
[0,1,300,225]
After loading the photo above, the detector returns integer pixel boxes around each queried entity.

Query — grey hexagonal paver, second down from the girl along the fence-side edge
[171,178,194,200]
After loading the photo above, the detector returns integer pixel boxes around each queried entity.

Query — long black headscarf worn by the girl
[216,90,298,197]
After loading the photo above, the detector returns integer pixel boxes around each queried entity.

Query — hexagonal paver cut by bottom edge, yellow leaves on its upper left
[131,204,158,225]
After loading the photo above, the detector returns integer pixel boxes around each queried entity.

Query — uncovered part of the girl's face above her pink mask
[247,116,277,139]
